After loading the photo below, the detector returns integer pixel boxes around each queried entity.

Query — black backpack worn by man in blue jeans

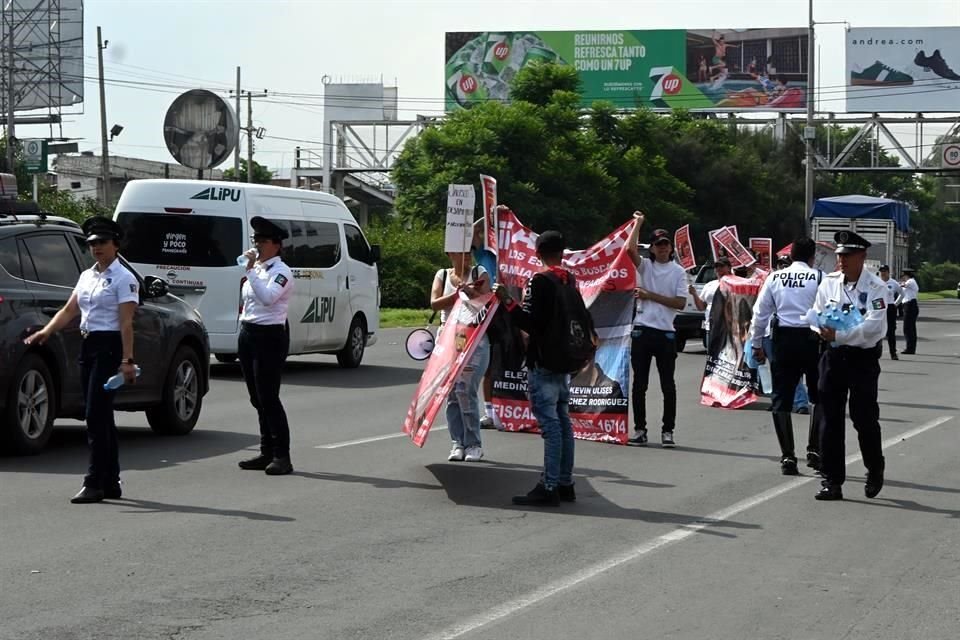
[537,272,597,373]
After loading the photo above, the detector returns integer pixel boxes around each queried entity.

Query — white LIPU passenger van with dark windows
[114,180,380,367]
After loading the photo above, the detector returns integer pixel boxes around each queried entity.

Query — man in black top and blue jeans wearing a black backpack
[495,231,596,506]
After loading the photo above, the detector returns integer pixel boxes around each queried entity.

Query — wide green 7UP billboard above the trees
[445,28,807,111]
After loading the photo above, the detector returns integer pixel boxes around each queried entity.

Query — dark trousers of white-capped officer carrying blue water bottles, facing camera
[818,343,884,486]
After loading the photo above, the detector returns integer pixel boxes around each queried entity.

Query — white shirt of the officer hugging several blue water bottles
[813,271,887,349]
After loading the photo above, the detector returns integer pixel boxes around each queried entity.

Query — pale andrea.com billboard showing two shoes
[846,27,960,113]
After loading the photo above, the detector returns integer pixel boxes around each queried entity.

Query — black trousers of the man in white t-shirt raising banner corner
[630,327,677,431]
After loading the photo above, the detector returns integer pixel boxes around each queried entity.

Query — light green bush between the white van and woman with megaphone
[366,217,449,309]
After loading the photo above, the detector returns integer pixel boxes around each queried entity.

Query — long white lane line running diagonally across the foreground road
[428,416,953,640]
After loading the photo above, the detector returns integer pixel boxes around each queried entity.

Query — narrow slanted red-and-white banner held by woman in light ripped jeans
[403,293,500,447]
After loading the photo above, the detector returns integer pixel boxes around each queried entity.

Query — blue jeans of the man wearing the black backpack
[527,368,573,491]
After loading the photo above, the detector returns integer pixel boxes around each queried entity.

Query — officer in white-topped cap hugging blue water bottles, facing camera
[812,231,888,500]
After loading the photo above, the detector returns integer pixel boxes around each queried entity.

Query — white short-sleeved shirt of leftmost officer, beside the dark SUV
[73,260,140,331]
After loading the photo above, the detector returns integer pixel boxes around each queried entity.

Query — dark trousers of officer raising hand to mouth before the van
[237,322,290,458]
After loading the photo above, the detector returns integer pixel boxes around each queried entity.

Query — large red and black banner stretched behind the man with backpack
[493,207,636,444]
